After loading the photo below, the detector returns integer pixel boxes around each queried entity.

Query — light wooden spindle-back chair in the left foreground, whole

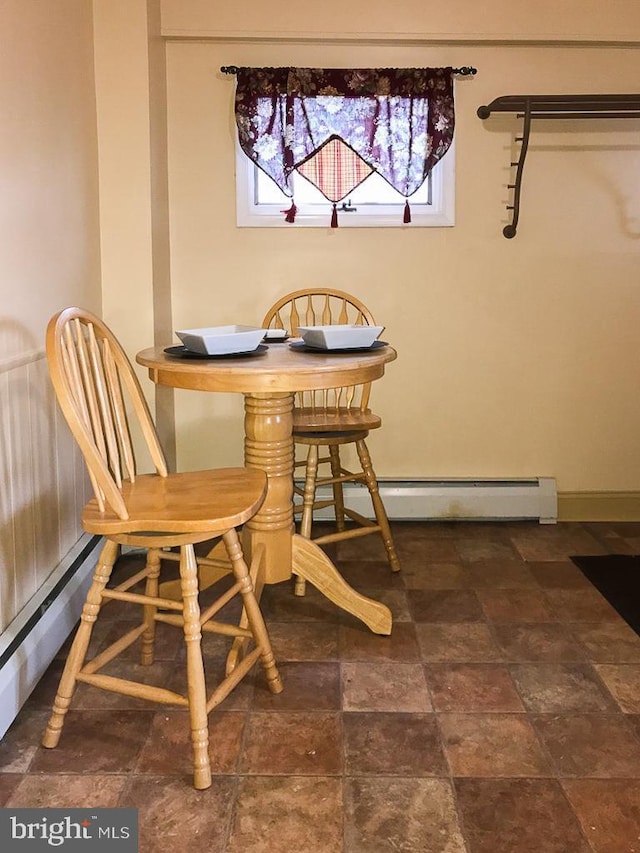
[42,308,282,788]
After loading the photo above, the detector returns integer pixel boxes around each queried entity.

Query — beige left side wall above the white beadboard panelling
[0,0,100,357]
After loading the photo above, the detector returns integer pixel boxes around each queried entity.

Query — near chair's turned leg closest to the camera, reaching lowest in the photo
[180,545,211,790]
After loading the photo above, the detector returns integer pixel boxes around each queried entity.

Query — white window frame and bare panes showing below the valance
[236,144,455,228]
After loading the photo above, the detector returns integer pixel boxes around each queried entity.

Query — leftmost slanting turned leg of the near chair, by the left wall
[42,540,120,749]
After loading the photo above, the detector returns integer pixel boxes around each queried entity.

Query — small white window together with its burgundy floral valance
[230,67,455,228]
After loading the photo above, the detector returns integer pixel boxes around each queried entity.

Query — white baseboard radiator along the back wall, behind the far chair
[302,477,558,524]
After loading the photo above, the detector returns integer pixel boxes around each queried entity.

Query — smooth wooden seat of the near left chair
[82,468,267,536]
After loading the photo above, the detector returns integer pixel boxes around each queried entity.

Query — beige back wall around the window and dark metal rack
[160,36,640,500]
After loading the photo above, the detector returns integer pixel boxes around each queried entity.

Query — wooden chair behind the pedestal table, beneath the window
[262,288,400,595]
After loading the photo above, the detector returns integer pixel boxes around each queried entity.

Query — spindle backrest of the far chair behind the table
[262,287,376,410]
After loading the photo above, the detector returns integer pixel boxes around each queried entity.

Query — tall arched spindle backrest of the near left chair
[47,308,167,519]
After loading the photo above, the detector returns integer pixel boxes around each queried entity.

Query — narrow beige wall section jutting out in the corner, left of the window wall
[93,0,153,366]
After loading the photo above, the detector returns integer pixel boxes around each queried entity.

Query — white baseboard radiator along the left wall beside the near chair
[0,534,102,738]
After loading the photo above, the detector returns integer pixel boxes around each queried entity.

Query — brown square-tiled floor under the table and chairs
[0,522,640,853]
